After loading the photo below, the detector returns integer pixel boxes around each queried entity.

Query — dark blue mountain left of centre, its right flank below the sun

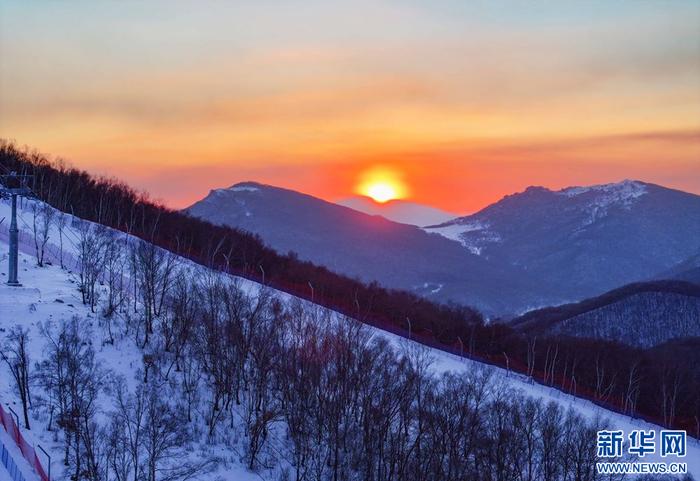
[186,182,549,314]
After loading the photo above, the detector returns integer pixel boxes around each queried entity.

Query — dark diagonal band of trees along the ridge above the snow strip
[0,137,700,437]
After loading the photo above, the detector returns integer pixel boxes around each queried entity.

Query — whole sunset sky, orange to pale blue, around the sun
[0,0,700,213]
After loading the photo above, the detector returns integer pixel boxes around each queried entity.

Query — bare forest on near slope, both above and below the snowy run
[0,142,700,481]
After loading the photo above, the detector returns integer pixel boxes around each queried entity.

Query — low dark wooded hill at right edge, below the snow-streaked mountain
[511,281,700,348]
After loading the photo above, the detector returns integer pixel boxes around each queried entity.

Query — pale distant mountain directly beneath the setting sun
[336,195,455,226]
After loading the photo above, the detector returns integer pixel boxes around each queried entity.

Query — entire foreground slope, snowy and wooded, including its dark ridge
[0,146,700,480]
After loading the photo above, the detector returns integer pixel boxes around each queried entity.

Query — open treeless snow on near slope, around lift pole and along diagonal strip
[0,197,700,481]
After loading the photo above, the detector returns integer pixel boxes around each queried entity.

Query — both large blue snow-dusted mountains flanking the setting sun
[187,181,700,316]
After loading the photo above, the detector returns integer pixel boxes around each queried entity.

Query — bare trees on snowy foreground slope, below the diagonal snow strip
[2,248,640,481]
